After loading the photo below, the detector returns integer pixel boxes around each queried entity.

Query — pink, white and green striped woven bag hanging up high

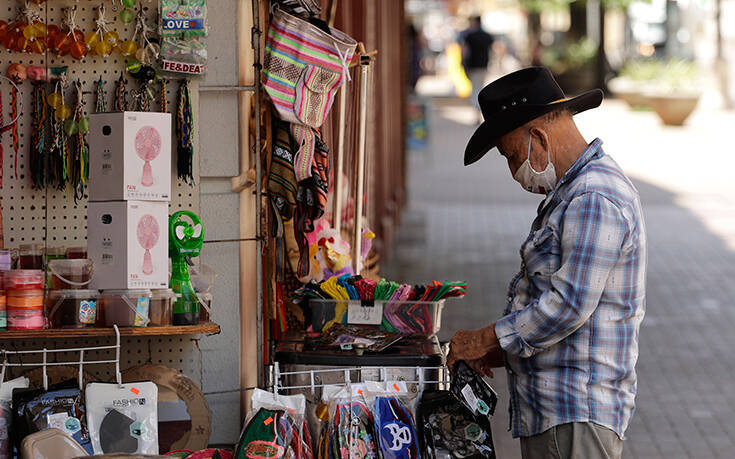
[263,8,357,128]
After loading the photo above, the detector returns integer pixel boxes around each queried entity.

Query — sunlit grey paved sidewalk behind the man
[383,100,735,459]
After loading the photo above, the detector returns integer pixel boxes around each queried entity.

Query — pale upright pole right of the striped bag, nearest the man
[352,51,370,274]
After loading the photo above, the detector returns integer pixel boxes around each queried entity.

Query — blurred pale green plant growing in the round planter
[620,59,699,90]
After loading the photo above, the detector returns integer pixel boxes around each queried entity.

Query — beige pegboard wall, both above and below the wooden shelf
[0,0,210,385]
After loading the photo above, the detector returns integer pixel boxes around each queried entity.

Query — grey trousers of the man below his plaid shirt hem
[521,422,623,459]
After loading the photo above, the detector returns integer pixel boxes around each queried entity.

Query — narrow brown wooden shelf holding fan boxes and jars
[0,322,220,341]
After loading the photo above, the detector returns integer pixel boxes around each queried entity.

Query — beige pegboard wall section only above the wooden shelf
[0,0,199,248]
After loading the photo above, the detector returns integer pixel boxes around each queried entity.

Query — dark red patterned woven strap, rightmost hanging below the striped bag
[296,131,329,277]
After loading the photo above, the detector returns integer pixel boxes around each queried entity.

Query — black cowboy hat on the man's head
[464,67,602,166]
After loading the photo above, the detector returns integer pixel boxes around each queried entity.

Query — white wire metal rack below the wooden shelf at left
[0,325,122,390]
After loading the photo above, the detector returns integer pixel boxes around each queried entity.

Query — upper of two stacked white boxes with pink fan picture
[88,112,172,201]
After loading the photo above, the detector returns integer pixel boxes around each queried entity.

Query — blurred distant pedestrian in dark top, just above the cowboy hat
[459,16,495,120]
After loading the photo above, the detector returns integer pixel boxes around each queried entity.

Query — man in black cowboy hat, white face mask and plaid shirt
[448,67,647,459]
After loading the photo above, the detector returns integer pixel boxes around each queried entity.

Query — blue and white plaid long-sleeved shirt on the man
[495,139,646,438]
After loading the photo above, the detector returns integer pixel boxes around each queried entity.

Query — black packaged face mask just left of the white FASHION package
[11,379,92,454]
